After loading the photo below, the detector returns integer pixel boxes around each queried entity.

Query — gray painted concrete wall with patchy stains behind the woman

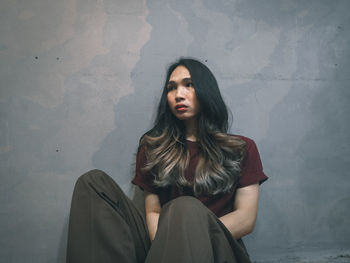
[0,0,350,262]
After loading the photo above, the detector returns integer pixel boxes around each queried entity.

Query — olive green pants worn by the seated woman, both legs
[67,170,250,263]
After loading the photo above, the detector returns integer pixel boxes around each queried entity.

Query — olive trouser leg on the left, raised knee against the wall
[67,170,150,263]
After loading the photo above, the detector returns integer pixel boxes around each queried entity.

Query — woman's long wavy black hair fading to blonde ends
[140,58,245,196]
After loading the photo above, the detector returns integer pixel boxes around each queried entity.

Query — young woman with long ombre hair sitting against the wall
[67,58,267,263]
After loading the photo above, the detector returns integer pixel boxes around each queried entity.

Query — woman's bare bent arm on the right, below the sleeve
[220,184,259,239]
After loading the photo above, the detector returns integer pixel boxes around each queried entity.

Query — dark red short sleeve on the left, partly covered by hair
[131,147,158,194]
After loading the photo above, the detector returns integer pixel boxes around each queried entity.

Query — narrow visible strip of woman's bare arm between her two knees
[144,191,161,241]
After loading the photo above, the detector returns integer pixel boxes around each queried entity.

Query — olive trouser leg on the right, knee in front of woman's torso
[145,196,250,263]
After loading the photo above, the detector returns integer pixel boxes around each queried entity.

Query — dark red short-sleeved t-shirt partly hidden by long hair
[132,135,268,217]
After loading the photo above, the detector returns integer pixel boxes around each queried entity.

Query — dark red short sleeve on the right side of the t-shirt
[238,137,268,188]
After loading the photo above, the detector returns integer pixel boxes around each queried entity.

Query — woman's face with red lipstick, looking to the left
[167,66,200,121]
